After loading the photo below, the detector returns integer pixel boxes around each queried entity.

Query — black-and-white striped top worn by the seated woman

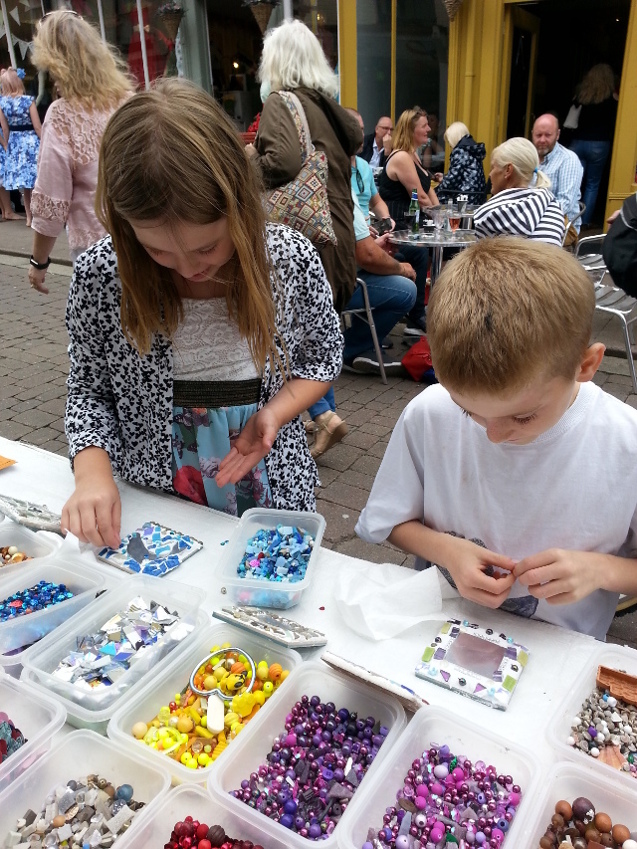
[473,188,564,246]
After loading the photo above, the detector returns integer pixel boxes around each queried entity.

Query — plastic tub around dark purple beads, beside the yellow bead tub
[208,662,406,849]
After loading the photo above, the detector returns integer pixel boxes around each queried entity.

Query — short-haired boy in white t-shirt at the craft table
[356,237,637,639]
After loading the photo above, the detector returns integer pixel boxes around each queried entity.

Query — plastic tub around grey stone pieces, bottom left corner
[0,731,170,846]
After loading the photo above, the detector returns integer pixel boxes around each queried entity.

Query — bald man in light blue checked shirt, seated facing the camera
[531,113,584,233]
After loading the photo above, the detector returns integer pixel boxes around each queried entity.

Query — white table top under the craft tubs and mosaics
[0,438,637,767]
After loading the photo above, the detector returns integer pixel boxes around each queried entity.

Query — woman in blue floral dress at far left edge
[0,68,42,227]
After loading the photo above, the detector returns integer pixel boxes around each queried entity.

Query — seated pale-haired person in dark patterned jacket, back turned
[436,121,487,204]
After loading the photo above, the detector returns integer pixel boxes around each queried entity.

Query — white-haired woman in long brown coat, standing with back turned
[246,21,363,458]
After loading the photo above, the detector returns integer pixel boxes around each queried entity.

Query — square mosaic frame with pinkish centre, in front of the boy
[415,619,529,710]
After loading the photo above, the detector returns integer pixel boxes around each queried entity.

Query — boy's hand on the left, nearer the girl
[441,537,515,608]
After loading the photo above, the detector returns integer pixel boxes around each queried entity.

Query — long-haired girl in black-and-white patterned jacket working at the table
[62,79,343,545]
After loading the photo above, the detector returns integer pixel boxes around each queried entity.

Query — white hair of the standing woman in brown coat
[259,21,339,98]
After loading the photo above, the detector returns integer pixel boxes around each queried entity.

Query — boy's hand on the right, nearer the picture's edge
[514,548,607,604]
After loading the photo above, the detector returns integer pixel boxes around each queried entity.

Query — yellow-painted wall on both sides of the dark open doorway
[447,0,637,224]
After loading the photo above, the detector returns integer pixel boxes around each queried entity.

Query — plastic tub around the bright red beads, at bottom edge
[117,784,288,849]
